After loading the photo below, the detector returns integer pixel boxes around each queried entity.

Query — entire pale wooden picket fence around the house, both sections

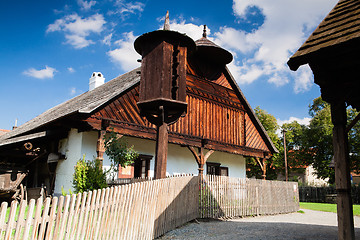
[0,176,299,239]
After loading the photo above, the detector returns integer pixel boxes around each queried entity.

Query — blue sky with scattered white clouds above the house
[0,0,337,129]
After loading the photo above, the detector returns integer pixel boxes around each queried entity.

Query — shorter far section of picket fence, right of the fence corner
[199,175,299,218]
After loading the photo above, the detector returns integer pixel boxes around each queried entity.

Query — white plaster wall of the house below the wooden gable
[54,129,246,194]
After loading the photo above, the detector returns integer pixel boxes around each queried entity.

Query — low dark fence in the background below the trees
[299,185,360,204]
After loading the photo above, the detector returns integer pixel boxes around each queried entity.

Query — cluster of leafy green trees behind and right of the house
[247,97,360,183]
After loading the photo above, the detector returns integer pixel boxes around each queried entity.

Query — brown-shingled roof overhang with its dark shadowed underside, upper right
[288,0,360,110]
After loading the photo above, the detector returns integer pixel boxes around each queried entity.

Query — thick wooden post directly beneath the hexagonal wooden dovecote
[154,122,169,179]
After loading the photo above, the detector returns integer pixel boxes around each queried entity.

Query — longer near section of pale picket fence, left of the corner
[0,176,199,240]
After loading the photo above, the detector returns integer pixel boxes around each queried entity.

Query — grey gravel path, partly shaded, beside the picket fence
[159,209,360,240]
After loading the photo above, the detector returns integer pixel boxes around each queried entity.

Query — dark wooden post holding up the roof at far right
[331,102,355,240]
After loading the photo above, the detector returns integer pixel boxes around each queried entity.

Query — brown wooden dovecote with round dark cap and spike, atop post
[134,13,195,125]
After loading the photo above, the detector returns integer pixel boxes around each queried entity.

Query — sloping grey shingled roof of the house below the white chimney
[0,68,140,143]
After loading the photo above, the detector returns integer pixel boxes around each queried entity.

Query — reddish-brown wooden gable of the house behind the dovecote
[86,62,271,157]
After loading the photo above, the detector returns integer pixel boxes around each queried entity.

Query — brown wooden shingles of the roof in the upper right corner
[288,0,360,70]
